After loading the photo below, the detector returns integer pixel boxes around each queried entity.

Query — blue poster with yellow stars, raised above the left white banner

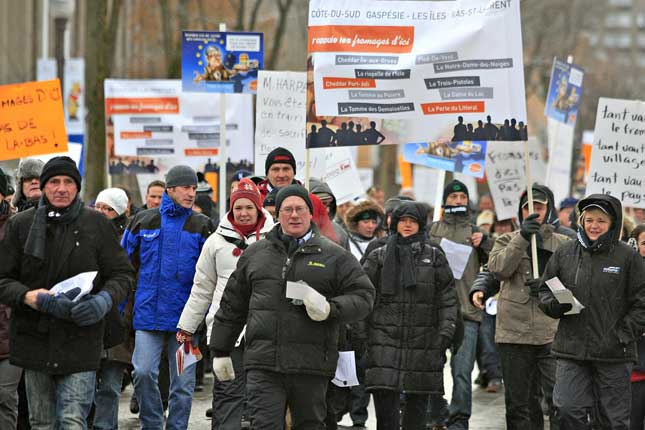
[181,31,264,93]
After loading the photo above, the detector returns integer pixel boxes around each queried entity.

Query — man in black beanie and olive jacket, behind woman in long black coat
[429,179,493,429]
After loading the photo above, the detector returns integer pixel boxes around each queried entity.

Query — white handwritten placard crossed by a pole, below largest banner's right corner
[486,138,546,220]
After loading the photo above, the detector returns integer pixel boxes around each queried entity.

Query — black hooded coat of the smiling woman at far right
[540,196,645,362]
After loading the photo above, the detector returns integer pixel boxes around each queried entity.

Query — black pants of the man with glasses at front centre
[246,369,331,430]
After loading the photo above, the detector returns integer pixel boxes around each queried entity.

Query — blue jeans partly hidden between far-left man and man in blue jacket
[94,360,127,430]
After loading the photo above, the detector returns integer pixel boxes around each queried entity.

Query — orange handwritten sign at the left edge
[0,79,67,160]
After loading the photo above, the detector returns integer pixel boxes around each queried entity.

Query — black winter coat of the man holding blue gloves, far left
[0,208,134,375]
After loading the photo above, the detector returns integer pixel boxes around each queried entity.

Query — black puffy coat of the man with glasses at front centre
[210,225,374,377]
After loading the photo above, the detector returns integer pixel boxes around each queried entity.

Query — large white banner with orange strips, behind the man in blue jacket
[105,79,253,175]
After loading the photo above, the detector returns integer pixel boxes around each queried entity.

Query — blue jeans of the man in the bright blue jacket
[132,330,197,430]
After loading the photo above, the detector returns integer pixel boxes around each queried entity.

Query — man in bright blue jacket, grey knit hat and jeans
[122,166,215,429]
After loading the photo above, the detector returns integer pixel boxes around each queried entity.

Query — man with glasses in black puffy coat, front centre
[210,185,374,430]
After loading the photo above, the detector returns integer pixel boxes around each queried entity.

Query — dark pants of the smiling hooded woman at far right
[553,358,632,430]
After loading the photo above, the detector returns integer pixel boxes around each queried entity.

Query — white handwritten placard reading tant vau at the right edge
[587,98,645,208]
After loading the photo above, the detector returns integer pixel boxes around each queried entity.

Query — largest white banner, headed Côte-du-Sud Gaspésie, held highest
[307,0,526,147]
